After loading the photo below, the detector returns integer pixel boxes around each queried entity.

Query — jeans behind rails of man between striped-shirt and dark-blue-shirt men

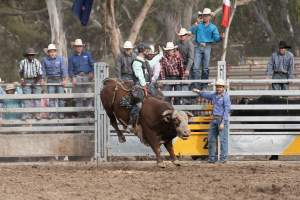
[47,77,65,107]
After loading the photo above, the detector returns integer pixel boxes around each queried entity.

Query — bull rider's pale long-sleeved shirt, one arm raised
[132,52,163,87]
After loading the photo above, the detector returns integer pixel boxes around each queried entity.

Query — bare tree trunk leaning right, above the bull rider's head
[128,0,154,43]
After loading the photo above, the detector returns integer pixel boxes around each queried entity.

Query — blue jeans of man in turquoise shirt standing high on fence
[192,44,211,88]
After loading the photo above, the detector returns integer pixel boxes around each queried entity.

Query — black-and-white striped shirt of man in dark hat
[19,58,43,79]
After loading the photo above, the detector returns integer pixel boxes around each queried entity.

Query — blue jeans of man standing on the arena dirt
[208,119,228,162]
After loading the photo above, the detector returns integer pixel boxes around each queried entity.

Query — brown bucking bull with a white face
[100,79,193,167]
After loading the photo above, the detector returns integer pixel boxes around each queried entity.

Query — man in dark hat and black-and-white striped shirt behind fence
[19,48,44,120]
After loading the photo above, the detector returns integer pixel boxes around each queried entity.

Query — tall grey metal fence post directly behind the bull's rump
[94,62,110,163]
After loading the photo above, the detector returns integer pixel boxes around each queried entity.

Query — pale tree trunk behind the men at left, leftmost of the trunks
[46,0,68,62]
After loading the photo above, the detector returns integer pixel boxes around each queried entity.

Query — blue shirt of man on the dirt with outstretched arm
[199,92,231,122]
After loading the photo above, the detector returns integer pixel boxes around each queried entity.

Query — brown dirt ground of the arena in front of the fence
[0,161,300,200]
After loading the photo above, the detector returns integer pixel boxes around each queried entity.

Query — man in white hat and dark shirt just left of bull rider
[116,41,136,80]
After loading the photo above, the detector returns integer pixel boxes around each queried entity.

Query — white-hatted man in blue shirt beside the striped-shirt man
[42,44,68,119]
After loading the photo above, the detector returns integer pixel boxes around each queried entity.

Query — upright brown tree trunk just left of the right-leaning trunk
[105,0,122,58]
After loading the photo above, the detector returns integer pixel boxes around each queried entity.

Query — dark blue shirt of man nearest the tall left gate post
[69,52,94,77]
